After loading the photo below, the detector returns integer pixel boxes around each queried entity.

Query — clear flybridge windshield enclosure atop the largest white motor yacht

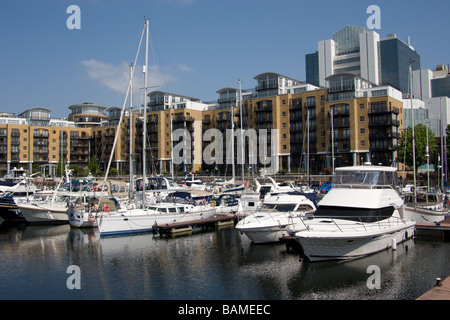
[333,170,397,188]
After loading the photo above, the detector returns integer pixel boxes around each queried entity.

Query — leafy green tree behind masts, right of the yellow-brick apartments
[398,124,437,168]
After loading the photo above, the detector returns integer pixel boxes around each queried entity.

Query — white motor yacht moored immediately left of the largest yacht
[236,192,316,243]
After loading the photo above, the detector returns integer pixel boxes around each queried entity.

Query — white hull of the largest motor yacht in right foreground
[295,221,415,262]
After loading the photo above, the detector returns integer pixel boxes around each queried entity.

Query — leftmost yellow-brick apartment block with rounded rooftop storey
[0,108,91,176]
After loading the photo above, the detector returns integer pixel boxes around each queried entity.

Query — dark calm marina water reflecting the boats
[0,222,450,300]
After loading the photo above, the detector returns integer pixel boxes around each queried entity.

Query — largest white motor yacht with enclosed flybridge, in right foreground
[288,166,415,261]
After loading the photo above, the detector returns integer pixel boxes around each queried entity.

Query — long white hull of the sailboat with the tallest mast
[97,208,216,235]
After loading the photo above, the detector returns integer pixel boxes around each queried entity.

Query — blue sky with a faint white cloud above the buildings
[0,0,450,118]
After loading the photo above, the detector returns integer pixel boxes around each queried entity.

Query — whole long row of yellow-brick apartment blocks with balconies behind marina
[0,72,403,175]
